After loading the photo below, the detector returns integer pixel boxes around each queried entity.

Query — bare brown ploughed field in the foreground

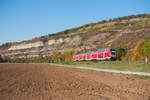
[0,64,150,100]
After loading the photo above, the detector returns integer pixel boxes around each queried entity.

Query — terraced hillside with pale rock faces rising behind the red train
[0,14,150,60]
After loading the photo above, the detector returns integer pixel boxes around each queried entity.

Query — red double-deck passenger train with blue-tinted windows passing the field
[73,48,117,62]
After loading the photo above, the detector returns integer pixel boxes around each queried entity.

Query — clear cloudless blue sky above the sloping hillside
[0,0,150,44]
